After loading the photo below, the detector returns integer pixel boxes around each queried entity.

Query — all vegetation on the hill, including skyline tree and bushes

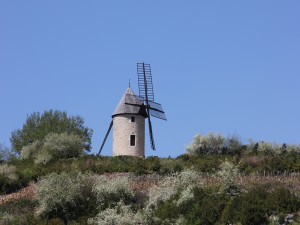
[0,111,300,225]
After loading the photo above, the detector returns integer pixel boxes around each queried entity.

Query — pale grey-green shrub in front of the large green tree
[21,132,84,164]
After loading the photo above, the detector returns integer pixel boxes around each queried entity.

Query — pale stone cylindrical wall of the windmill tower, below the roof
[113,115,145,157]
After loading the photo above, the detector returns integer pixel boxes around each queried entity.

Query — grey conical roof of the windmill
[112,87,147,117]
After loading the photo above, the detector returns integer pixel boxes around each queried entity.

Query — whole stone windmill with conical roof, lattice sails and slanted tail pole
[97,63,167,157]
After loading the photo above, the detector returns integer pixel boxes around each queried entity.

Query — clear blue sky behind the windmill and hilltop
[0,0,300,157]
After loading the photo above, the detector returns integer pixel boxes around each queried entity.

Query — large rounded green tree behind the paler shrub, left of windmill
[10,110,93,152]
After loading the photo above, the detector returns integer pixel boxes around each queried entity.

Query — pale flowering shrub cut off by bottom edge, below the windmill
[88,202,149,225]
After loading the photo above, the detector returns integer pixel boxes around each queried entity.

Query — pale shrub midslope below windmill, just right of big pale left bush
[93,176,135,209]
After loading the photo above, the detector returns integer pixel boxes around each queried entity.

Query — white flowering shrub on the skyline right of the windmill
[186,133,225,155]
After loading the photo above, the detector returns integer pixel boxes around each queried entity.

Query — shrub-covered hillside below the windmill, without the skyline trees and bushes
[0,154,300,224]
